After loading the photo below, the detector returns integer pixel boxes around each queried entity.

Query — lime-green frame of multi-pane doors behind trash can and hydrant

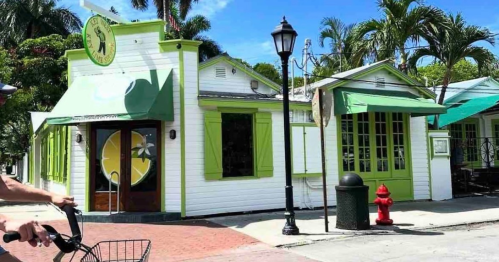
[337,112,413,192]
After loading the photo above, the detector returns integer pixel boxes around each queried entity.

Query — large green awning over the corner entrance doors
[47,69,173,125]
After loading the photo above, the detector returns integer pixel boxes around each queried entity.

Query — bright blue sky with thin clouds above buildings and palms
[60,0,499,68]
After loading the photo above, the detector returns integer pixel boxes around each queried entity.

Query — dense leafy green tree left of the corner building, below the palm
[0,34,83,161]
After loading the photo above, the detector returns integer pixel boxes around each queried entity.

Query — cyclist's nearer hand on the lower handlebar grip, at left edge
[0,217,51,247]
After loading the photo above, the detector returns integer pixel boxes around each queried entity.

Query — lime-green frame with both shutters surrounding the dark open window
[204,108,274,181]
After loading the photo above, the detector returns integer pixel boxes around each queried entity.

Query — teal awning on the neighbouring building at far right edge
[428,95,499,128]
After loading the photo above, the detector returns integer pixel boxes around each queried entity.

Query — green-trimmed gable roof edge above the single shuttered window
[199,53,281,92]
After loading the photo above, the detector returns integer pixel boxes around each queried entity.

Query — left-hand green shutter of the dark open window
[204,111,223,180]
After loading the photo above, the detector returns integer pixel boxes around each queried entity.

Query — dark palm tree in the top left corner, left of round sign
[0,0,83,47]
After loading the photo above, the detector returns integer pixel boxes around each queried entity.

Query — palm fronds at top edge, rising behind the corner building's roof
[131,0,198,21]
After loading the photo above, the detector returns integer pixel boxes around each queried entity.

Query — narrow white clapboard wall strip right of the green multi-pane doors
[409,117,430,200]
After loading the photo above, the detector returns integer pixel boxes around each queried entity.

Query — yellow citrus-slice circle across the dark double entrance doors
[101,131,151,186]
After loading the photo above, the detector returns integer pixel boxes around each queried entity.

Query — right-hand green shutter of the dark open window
[255,113,274,177]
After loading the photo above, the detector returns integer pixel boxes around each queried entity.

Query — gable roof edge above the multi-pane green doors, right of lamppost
[310,59,436,98]
